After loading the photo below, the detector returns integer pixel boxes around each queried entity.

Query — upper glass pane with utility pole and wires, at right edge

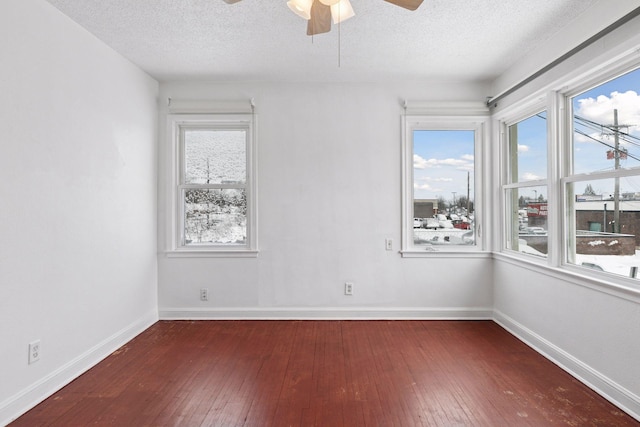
[572,70,640,174]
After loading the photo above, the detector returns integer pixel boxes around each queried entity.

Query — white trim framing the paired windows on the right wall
[492,46,640,294]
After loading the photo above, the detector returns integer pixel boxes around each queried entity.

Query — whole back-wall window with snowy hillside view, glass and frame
[170,115,256,255]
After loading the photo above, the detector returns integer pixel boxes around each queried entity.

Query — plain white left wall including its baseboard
[0,0,158,424]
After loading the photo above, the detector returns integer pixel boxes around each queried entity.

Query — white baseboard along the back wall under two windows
[159,307,493,320]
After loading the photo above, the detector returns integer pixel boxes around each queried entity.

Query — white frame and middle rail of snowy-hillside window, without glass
[167,113,258,257]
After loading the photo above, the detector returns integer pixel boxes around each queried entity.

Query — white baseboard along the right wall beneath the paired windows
[493,310,640,421]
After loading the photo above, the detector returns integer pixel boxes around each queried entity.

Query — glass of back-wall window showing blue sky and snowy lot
[413,130,475,245]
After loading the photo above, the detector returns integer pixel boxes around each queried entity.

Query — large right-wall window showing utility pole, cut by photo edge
[563,70,640,278]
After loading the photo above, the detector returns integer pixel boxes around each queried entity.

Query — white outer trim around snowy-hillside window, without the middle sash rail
[166,112,259,258]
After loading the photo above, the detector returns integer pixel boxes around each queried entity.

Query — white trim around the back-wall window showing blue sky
[400,103,489,258]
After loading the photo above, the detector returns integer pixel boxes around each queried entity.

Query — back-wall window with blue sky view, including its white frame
[402,111,485,256]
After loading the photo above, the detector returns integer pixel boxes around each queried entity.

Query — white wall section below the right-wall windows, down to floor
[494,260,640,419]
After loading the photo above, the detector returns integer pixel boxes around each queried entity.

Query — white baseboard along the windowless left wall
[0,310,158,425]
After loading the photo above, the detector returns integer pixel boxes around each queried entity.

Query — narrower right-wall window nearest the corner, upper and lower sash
[503,111,548,257]
